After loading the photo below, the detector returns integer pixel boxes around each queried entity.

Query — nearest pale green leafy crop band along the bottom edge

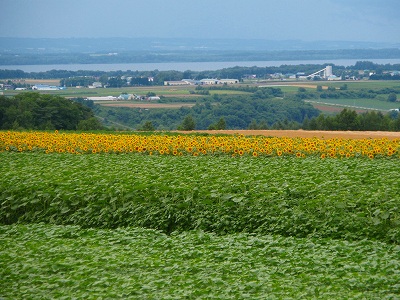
[0,224,400,299]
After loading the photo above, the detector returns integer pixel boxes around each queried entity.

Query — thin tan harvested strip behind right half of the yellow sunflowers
[186,130,400,139]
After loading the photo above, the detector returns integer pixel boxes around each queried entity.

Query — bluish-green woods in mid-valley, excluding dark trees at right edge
[95,89,319,130]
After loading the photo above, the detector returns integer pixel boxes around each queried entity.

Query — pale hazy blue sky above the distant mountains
[0,0,400,42]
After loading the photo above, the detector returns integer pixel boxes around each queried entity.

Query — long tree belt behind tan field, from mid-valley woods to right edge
[99,97,400,131]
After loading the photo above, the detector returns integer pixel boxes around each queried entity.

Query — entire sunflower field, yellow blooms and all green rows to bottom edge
[0,131,400,299]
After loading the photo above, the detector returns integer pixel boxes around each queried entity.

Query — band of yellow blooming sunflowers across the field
[0,131,400,159]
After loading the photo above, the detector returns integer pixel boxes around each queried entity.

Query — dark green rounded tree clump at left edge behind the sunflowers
[0,92,104,130]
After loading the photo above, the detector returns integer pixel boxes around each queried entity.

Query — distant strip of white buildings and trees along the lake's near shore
[0,61,400,97]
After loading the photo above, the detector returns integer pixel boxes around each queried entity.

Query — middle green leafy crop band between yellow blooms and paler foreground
[0,152,400,243]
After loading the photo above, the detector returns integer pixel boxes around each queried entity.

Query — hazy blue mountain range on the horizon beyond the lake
[0,37,400,54]
